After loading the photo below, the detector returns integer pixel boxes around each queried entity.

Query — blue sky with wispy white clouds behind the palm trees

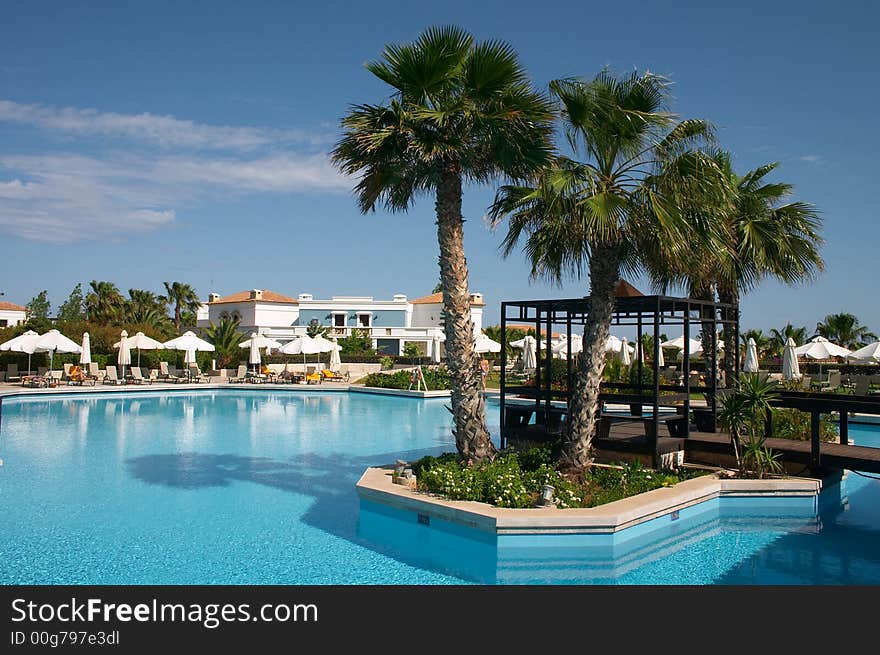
[0,0,880,332]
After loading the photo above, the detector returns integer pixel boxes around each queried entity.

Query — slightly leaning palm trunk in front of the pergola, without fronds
[562,246,620,470]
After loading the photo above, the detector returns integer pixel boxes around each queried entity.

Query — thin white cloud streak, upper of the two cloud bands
[0,100,332,151]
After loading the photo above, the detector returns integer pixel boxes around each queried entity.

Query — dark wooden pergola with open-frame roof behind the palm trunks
[500,280,739,458]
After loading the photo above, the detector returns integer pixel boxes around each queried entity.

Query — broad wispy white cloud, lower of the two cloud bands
[0,153,351,243]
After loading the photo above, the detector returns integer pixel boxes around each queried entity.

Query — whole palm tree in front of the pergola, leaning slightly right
[490,71,720,469]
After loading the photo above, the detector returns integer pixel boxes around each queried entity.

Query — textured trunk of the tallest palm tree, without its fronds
[435,160,497,464]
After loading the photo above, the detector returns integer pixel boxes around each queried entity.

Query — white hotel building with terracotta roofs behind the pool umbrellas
[197,289,485,355]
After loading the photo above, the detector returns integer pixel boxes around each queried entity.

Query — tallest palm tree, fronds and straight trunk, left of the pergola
[332,26,553,462]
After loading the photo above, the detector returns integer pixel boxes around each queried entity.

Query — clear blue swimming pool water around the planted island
[0,390,880,584]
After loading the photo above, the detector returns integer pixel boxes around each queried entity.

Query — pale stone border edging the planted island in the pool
[356,468,822,535]
